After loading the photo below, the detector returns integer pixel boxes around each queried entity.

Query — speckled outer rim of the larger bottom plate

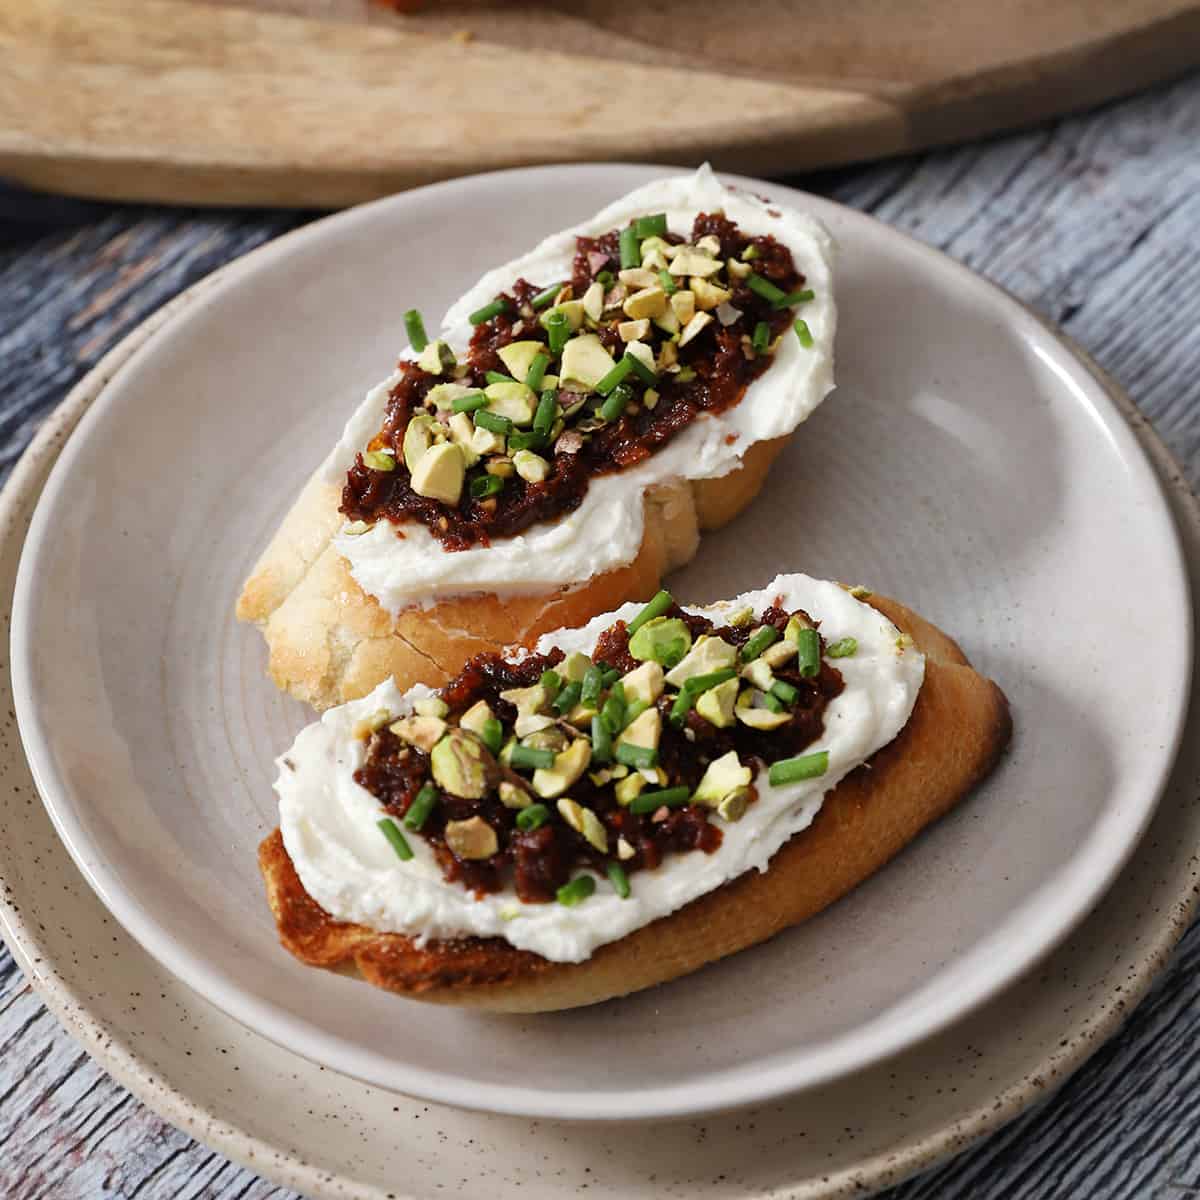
[0,206,1200,1200]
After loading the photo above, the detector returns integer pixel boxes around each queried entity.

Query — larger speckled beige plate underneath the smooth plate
[0,180,1200,1200]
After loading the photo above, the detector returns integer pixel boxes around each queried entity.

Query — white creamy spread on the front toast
[275,575,925,962]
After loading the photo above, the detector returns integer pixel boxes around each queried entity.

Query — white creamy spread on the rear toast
[325,166,838,614]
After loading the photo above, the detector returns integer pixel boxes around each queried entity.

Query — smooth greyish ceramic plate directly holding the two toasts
[13,167,1192,1118]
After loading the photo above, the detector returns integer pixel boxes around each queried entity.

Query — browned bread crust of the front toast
[258,596,1012,1013]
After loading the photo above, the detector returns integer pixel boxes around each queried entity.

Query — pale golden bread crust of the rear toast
[238,438,786,709]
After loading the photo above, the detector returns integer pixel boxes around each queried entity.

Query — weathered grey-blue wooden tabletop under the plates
[0,76,1200,1200]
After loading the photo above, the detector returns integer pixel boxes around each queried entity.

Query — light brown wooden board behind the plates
[0,0,1200,208]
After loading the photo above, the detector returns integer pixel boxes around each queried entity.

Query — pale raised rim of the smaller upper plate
[4,163,1192,1121]
